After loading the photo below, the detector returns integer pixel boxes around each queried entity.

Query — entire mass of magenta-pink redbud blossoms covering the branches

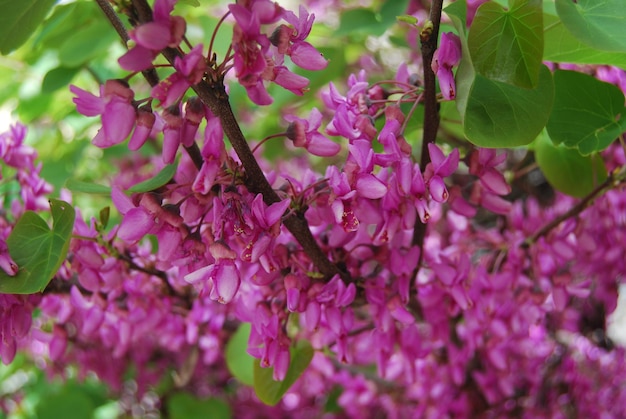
[0,0,626,418]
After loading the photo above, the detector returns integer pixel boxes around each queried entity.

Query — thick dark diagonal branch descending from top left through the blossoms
[106,0,342,280]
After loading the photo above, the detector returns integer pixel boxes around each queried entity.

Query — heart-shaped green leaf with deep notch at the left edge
[0,199,75,294]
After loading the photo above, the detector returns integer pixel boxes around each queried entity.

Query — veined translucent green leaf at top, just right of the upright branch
[468,0,543,88]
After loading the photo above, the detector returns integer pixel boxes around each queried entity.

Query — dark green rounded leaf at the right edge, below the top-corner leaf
[547,70,626,155]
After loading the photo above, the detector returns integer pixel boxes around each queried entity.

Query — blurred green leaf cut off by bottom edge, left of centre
[167,393,232,419]
